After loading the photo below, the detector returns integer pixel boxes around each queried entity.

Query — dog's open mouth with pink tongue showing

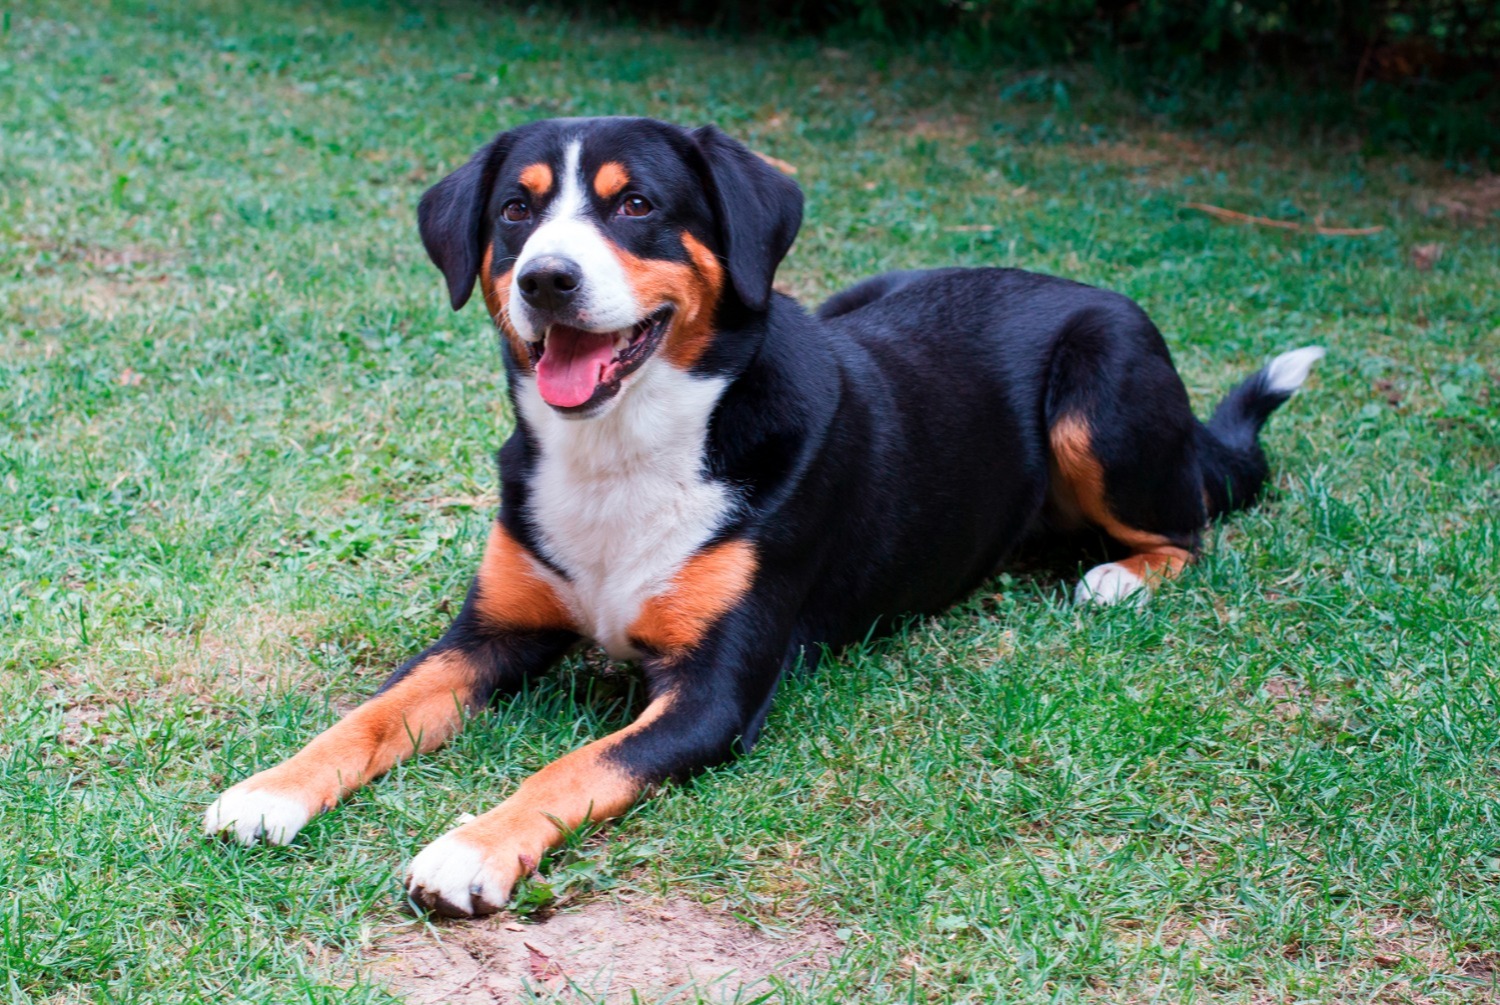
[530,305,672,411]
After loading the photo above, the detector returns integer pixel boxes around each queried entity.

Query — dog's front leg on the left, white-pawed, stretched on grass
[204,524,578,845]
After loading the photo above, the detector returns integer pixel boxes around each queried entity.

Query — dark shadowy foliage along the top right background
[591,0,1500,164]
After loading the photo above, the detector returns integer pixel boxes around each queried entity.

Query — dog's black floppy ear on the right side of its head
[693,126,803,311]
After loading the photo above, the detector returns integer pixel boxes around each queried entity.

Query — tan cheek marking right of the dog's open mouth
[614,231,725,371]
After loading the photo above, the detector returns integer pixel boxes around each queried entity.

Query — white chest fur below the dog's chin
[516,362,734,659]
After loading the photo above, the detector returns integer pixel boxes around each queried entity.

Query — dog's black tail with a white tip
[1197,345,1323,518]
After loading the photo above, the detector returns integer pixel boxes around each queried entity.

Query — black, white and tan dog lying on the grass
[206,119,1322,917]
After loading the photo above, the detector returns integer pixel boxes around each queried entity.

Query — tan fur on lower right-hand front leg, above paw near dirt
[438,696,672,885]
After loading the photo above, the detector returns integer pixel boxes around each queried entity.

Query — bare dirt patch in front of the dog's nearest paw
[374,900,843,1005]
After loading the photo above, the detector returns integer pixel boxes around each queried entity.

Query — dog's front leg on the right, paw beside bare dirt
[407,591,789,918]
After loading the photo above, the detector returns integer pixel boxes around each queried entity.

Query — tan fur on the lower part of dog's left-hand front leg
[242,651,479,815]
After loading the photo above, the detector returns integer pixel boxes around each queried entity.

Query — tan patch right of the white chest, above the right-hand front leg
[630,542,758,659]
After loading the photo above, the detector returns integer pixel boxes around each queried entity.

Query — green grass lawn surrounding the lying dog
[0,0,1500,1004]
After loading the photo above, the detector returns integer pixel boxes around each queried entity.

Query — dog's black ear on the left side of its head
[417,132,512,311]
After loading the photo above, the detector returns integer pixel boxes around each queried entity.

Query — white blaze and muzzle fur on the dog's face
[509,140,642,342]
